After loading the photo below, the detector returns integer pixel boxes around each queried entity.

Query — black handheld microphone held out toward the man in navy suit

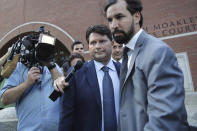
[49,61,83,101]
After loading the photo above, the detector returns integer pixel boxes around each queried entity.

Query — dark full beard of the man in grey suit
[112,25,134,44]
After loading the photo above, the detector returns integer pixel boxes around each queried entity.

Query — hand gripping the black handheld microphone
[53,76,69,93]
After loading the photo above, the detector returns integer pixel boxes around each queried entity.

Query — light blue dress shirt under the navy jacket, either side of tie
[94,60,120,131]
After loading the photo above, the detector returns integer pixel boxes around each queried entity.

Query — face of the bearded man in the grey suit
[106,1,135,44]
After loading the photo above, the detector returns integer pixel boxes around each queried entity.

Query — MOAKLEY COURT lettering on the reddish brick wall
[144,16,197,37]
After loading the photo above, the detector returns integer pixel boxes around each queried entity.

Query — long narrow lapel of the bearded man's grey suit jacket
[121,31,145,89]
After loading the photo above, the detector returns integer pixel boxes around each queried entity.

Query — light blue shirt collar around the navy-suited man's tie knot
[94,59,116,72]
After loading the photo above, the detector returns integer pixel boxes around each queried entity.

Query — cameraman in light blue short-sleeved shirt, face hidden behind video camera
[0,31,61,131]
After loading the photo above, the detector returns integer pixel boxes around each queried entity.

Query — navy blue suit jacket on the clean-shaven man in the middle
[59,60,120,131]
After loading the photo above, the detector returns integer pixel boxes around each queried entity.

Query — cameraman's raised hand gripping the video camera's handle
[26,67,40,86]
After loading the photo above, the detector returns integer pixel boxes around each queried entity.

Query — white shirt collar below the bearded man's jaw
[125,29,143,50]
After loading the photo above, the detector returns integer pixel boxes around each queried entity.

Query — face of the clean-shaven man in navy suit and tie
[89,33,112,65]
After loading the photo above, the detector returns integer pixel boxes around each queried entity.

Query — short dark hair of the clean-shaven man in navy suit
[86,24,112,44]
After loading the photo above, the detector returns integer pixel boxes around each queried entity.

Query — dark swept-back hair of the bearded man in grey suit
[104,0,143,27]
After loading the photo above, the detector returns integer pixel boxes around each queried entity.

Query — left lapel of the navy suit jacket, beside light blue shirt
[87,60,101,111]
